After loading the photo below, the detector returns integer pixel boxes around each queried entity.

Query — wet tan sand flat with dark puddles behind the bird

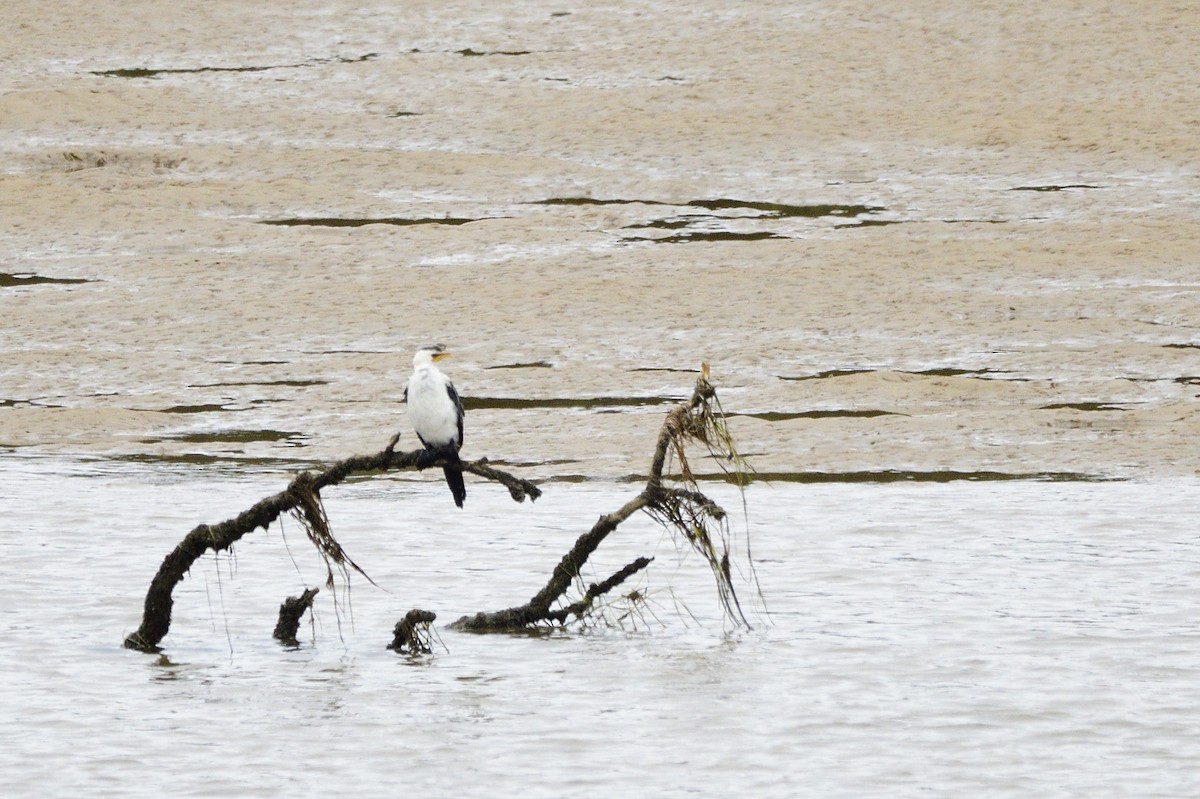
[0,0,1200,480]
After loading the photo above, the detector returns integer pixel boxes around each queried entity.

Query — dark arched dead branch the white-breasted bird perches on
[125,438,541,651]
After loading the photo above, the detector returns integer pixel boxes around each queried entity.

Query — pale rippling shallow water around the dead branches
[0,456,1200,797]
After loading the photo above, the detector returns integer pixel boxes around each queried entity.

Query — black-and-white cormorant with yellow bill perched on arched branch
[404,344,467,507]
